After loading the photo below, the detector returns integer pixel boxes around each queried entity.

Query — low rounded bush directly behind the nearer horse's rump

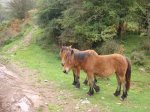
[96,40,124,54]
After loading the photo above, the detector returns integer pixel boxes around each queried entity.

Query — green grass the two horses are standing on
[1,28,150,112]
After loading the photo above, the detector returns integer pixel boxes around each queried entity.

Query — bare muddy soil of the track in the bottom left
[0,63,102,112]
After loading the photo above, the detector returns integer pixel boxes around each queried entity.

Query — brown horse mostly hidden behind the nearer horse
[60,46,98,88]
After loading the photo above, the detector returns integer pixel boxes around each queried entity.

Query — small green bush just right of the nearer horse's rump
[131,51,145,66]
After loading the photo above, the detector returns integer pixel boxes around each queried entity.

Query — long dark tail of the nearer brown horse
[125,58,131,91]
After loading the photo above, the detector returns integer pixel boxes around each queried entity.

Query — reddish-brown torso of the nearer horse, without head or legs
[85,54,127,76]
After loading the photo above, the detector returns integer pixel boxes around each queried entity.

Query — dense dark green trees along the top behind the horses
[38,0,150,49]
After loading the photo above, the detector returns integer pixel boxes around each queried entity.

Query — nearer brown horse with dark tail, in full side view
[64,50,131,100]
